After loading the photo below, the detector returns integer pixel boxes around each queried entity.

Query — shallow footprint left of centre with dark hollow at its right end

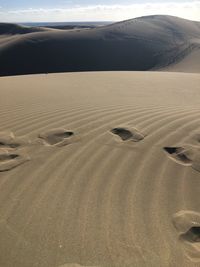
[38,129,76,146]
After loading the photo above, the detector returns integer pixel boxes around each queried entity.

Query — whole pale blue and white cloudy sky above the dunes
[0,0,200,22]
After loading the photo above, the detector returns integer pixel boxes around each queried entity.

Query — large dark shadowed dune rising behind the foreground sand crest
[0,15,200,76]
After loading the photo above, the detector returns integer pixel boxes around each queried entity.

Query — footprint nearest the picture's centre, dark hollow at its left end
[111,127,144,142]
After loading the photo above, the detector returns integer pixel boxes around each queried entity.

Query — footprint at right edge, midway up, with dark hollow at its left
[163,145,200,172]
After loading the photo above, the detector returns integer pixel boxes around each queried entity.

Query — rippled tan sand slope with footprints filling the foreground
[0,72,200,267]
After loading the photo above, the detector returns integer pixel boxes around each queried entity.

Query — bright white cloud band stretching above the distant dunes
[0,1,200,22]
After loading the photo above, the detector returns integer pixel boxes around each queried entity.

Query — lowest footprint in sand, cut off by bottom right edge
[173,210,200,262]
